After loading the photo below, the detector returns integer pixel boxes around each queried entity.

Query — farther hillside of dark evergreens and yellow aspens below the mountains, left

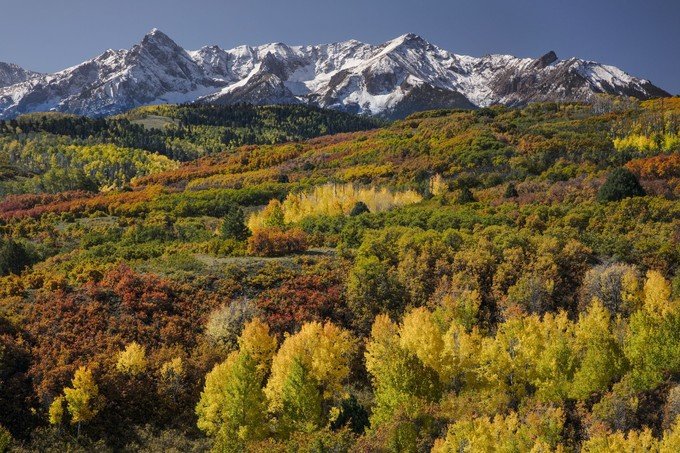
[0,105,379,195]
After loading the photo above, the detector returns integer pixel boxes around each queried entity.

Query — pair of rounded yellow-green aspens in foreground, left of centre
[196,318,356,451]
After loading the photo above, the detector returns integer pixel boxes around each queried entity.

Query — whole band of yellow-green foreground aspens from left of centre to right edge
[183,272,680,452]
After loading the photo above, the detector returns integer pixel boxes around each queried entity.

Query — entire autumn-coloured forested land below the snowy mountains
[0,98,680,452]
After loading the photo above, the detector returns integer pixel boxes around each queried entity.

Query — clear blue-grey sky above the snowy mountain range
[0,0,680,94]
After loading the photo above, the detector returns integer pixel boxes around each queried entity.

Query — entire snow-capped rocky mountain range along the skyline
[0,29,669,118]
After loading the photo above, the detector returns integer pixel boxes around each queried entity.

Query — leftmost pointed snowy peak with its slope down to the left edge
[0,29,220,117]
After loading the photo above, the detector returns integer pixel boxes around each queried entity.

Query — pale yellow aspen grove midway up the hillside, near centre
[248,184,422,230]
